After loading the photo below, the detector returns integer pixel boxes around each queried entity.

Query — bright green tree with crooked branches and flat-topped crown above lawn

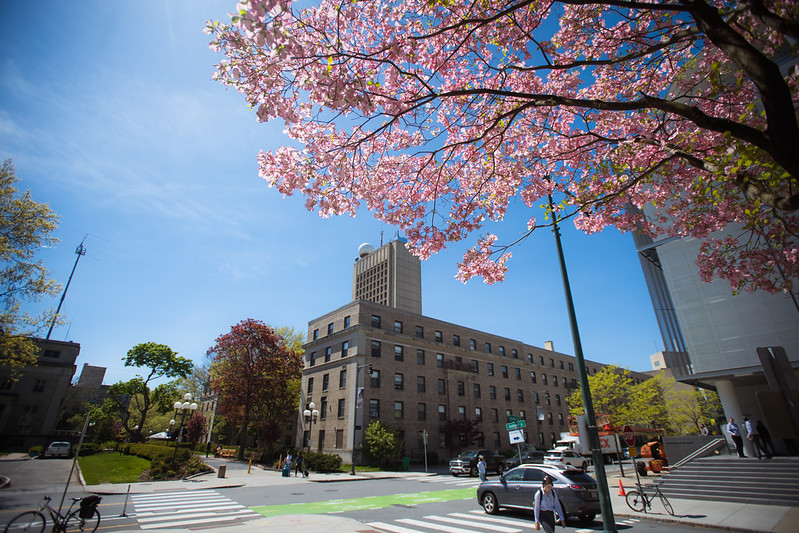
[105,342,194,440]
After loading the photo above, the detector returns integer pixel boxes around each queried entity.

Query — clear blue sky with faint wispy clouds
[0,0,663,384]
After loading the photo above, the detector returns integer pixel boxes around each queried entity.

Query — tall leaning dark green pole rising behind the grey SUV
[549,194,616,533]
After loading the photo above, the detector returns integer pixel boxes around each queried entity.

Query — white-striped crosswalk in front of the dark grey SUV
[367,510,637,533]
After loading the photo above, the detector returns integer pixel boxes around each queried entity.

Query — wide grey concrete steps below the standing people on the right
[657,456,799,507]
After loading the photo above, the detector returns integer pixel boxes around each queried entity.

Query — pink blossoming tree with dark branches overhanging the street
[207,0,799,292]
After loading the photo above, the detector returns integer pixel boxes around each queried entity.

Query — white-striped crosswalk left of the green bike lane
[131,490,263,529]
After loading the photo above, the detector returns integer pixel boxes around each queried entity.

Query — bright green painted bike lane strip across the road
[250,487,477,517]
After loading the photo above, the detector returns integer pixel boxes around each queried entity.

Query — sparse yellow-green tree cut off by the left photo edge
[0,159,60,378]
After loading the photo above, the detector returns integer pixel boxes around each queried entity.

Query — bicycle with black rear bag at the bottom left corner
[3,496,100,533]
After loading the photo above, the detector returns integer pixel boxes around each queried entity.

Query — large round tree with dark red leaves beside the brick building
[208,318,302,459]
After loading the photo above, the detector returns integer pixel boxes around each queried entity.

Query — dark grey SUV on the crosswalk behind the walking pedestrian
[477,465,600,522]
